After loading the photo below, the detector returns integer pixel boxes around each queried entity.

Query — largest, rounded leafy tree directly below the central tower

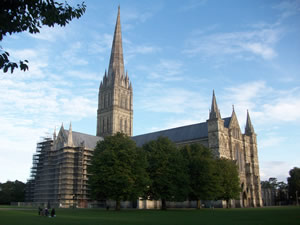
[88,133,149,210]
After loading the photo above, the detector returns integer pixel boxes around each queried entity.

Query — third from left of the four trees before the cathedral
[181,144,220,209]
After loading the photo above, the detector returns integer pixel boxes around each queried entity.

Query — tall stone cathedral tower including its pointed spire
[97,7,133,137]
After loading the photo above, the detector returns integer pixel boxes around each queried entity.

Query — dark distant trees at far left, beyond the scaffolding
[0,180,25,204]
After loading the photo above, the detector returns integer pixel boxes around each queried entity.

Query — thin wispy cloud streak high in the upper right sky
[183,28,281,60]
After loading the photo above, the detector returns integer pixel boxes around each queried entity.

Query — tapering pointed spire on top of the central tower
[108,6,124,80]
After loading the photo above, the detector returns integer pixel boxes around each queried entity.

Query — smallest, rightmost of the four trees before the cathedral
[216,158,241,208]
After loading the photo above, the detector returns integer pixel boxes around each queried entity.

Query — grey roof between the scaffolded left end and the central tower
[65,130,104,149]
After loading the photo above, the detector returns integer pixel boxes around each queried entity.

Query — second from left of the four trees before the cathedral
[143,137,189,210]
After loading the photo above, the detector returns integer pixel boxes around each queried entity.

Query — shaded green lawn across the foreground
[0,207,300,225]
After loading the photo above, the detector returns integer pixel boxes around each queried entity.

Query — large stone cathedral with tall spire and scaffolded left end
[27,8,262,208]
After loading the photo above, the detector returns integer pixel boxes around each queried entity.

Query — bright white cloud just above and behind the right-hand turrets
[217,81,300,125]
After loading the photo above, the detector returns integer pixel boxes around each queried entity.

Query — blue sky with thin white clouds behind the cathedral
[0,0,300,182]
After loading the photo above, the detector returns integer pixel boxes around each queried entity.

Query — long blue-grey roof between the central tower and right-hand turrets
[132,117,231,146]
